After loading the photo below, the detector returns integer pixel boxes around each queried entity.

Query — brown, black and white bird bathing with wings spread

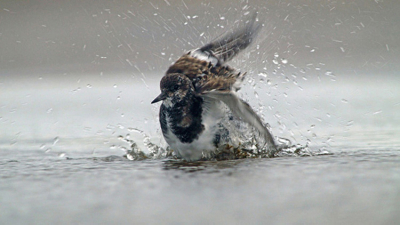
[151,13,277,161]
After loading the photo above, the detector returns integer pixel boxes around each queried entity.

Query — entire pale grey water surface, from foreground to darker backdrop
[0,74,400,224]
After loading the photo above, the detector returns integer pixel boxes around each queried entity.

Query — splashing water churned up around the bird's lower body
[115,113,331,161]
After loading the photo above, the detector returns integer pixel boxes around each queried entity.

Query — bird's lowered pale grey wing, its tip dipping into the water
[204,90,277,157]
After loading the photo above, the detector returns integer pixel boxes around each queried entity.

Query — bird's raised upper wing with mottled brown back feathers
[167,13,260,93]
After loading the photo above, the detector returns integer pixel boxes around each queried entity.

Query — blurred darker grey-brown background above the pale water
[0,0,400,76]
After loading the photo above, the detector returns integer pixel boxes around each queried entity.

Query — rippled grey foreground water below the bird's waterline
[0,140,400,224]
